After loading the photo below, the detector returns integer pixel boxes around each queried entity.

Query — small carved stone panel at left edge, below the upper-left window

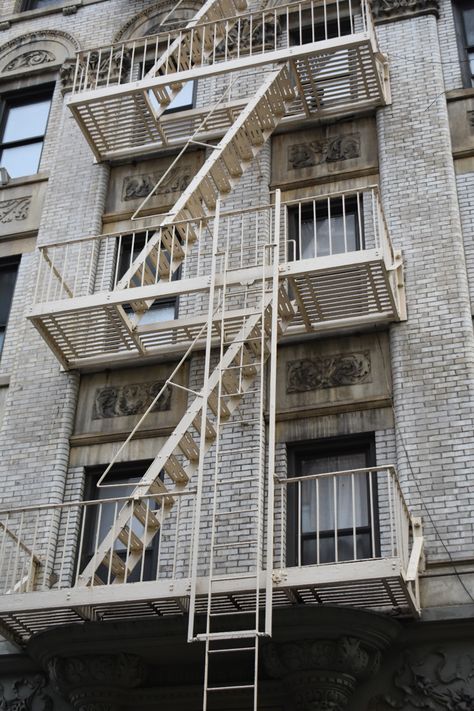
[0,178,47,237]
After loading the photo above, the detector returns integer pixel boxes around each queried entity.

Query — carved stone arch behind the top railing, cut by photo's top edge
[114,0,202,42]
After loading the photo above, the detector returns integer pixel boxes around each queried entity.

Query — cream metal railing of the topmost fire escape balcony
[73,0,375,94]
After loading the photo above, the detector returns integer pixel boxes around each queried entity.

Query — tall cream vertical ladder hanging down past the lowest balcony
[188,196,286,711]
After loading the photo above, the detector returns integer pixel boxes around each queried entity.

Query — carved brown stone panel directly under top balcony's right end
[272,118,378,187]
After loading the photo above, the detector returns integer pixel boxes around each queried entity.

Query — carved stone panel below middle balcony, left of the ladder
[72,363,188,444]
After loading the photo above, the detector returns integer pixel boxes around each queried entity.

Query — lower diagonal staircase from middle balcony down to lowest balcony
[77,287,294,586]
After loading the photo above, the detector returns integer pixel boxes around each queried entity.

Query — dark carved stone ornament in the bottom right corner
[369,651,474,711]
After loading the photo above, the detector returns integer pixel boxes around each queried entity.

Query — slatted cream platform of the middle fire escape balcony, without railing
[28,249,405,369]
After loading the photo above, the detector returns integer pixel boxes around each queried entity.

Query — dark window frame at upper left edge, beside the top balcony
[0,82,54,179]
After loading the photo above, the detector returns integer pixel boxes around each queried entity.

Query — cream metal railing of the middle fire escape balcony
[34,187,395,304]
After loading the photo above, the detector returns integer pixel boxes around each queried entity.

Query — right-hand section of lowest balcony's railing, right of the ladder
[275,466,414,571]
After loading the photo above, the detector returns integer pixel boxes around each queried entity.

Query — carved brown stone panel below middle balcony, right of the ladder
[277,333,391,418]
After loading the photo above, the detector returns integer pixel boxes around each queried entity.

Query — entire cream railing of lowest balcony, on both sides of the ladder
[0,465,418,595]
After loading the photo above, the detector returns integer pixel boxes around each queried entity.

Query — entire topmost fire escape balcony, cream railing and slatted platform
[69,0,388,160]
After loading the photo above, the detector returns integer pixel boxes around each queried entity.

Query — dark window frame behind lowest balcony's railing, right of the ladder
[286,433,380,567]
